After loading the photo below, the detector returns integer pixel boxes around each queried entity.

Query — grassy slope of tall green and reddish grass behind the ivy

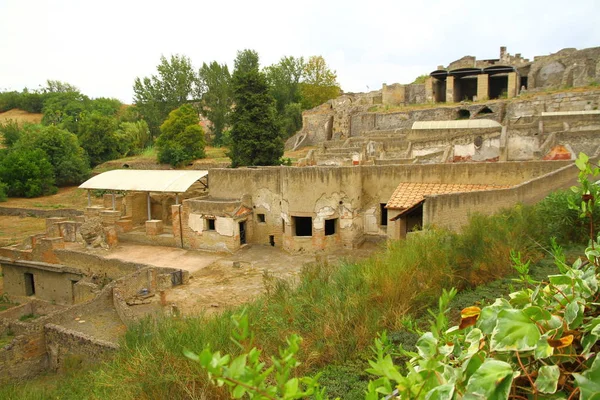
[0,203,556,399]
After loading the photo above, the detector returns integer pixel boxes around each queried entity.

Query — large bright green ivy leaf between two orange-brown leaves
[490,310,541,351]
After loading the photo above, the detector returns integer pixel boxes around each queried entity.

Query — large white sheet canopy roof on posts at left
[79,169,208,193]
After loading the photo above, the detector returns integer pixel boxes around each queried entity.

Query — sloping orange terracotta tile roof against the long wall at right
[385,182,510,210]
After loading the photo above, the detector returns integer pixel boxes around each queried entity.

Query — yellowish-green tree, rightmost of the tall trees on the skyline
[300,56,341,110]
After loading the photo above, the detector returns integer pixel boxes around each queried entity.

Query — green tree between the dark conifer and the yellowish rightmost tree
[265,56,305,137]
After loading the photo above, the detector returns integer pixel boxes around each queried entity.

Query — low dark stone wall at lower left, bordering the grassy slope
[44,324,119,371]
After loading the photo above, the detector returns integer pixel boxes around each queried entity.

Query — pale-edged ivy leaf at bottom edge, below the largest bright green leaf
[463,359,515,400]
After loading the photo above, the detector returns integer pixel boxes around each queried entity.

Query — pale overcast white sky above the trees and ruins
[0,0,600,103]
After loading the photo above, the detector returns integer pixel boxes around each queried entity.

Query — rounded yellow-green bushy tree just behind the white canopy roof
[156,104,205,166]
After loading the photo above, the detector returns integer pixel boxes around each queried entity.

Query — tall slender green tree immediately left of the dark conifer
[197,61,232,146]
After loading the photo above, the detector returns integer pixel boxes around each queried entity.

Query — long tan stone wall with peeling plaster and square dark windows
[199,161,570,252]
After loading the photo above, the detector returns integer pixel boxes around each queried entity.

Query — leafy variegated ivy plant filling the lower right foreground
[367,155,600,399]
